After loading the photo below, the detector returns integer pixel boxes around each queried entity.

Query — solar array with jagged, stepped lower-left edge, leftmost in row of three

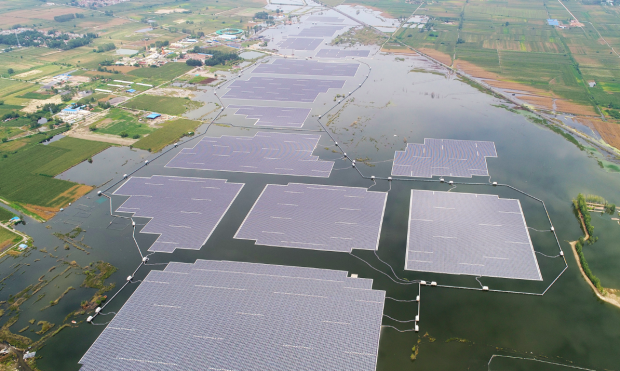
[114,175,243,253]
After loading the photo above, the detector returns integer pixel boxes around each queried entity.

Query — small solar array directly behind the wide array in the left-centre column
[227,104,311,128]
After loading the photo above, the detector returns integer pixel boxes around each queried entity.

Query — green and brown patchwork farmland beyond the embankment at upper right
[382,0,620,120]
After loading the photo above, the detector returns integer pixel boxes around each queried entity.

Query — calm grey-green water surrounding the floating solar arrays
[0,56,620,371]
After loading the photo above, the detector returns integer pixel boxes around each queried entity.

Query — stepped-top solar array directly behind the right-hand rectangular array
[392,138,497,178]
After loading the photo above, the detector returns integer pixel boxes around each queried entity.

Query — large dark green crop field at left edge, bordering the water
[0,138,110,214]
